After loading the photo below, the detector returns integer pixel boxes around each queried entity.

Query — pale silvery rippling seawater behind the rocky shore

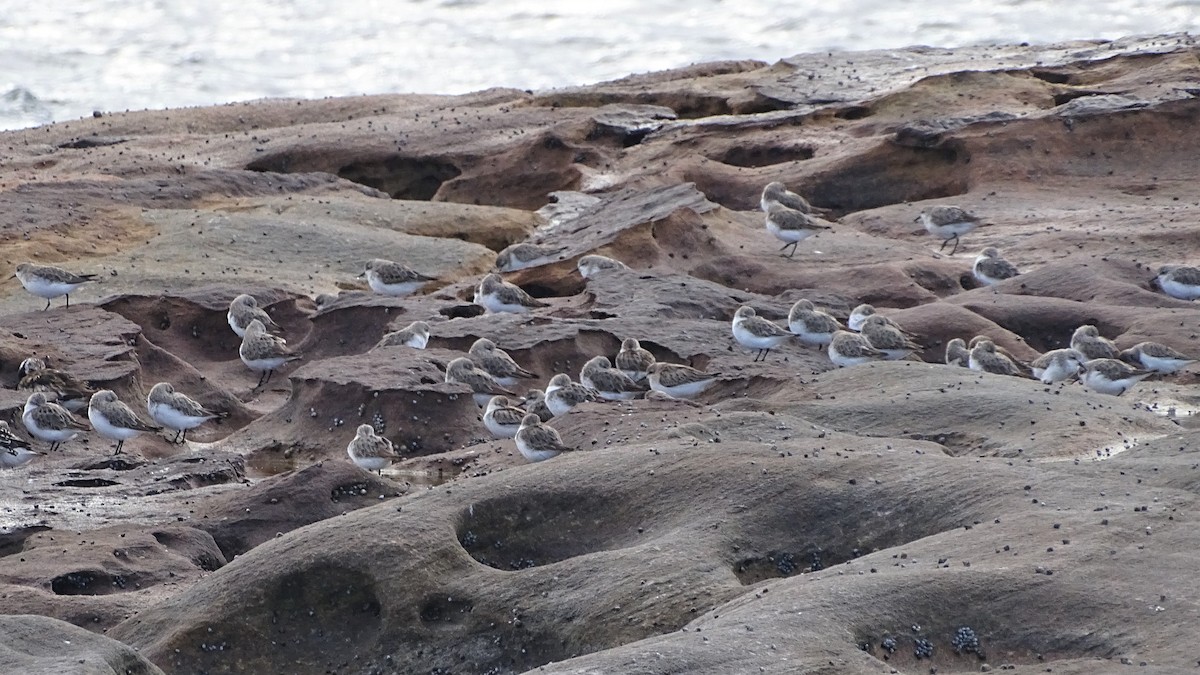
[0,0,1200,129]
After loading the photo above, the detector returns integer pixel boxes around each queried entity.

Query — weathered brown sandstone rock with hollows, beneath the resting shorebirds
[0,36,1200,674]
